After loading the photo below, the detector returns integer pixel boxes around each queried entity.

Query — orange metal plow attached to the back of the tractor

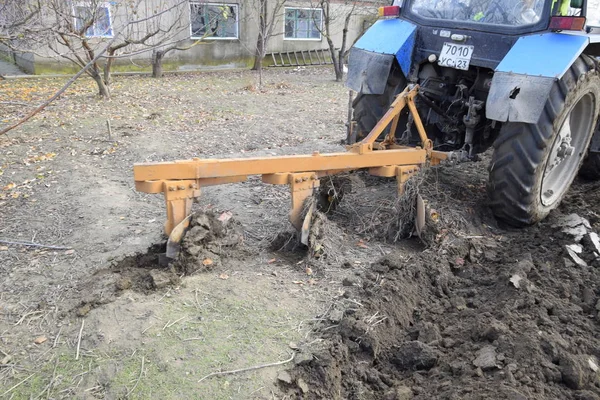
[134,86,447,250]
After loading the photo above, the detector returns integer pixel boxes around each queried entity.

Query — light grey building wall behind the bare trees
[10,0,380,74]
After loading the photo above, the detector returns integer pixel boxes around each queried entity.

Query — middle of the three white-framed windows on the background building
[190,3,238,39]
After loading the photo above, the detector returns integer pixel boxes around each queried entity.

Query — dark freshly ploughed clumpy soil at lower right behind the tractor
[283,164,600,399]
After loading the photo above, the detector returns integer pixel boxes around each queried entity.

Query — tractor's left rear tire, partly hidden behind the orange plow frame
[347,63,406,144]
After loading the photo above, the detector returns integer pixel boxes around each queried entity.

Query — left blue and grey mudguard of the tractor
[346,19,417,94]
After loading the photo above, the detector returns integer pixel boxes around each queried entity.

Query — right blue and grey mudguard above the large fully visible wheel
[486,33,589,124]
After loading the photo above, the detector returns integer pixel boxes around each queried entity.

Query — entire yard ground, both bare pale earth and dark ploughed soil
[0,68,600,400]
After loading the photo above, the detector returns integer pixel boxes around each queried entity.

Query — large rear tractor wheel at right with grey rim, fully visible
[488,56,600,227]
